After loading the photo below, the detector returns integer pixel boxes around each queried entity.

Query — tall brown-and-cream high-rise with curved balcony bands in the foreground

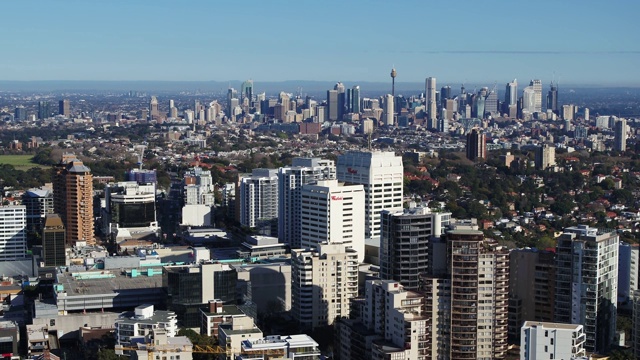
[423,221,509,360]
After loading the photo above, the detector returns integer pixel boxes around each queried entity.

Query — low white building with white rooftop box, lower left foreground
[115,304,178,345]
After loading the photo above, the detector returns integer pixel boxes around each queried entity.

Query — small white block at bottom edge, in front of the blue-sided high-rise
[520,321,586,360]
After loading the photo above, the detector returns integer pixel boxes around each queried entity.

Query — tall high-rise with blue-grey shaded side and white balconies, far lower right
[555,225,619,353]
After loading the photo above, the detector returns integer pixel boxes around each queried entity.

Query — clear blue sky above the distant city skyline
[0,0,640,86]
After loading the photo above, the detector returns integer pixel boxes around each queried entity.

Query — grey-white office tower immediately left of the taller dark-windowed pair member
[240,169,278,236]
